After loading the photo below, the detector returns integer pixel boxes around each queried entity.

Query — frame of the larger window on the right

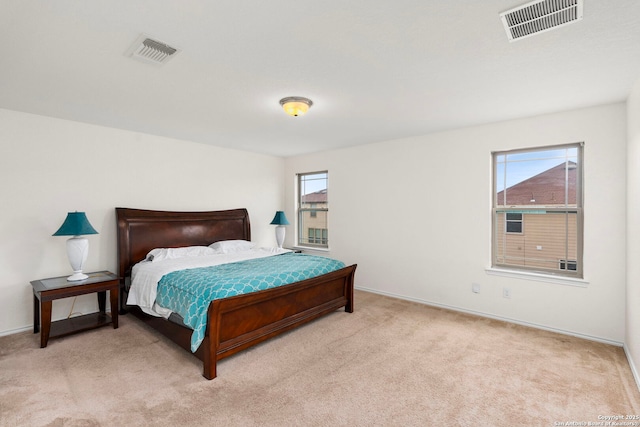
[491,142,584,281]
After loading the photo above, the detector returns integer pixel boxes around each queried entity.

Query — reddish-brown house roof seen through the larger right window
[497,162,577,206]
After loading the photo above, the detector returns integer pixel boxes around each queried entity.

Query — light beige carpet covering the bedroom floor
[0,292,640,427]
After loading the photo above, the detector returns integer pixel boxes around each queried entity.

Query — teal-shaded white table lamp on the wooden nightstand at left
[53,212,98,282]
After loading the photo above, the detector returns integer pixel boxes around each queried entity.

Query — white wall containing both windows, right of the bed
[285,103,627,344]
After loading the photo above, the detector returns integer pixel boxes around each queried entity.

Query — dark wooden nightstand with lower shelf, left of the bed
[31,271,120,348]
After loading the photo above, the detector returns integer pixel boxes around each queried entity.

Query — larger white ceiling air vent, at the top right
[500,0,583,42]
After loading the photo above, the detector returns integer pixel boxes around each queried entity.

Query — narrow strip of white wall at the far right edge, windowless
[625,79,640,387]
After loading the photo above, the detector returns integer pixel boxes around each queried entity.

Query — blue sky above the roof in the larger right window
[496,147,578,192]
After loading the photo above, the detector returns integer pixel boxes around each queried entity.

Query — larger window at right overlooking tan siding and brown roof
[492,144,583,278]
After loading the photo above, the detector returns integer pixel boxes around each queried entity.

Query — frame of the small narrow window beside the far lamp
[296,170,329,250]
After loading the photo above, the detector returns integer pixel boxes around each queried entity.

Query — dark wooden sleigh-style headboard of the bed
[116,208,251,280]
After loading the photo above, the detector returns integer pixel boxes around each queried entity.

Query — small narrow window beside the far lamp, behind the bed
[298,171,329,248]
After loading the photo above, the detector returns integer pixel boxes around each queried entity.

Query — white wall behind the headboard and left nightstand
[0,109,284,335]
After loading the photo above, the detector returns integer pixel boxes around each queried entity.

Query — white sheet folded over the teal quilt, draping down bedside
[127,248,290,318]
